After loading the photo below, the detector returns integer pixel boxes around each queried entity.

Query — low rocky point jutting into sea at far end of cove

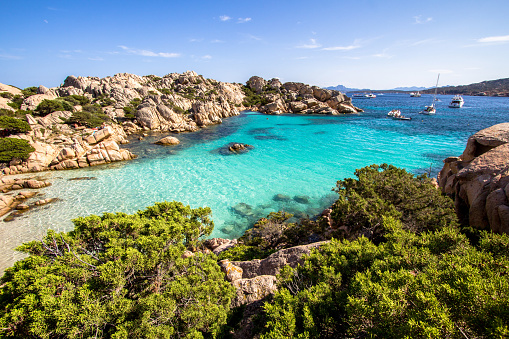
[247,76,362,115]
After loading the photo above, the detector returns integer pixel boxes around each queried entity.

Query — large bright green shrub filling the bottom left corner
[0,202,234,338]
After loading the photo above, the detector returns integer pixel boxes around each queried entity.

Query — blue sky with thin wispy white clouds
[0,0,509,89]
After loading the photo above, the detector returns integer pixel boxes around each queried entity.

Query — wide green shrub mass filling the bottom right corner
[262,217,509,338]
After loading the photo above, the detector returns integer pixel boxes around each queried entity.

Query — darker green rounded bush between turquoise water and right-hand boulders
[331,164,457,237]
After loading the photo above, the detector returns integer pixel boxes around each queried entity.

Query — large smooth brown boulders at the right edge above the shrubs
[438,123,509,234]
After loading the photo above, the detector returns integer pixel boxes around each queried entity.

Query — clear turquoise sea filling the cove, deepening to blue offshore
[0,94,509,272]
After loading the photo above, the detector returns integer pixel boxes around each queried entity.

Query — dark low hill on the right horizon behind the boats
[423,78,509,97]
